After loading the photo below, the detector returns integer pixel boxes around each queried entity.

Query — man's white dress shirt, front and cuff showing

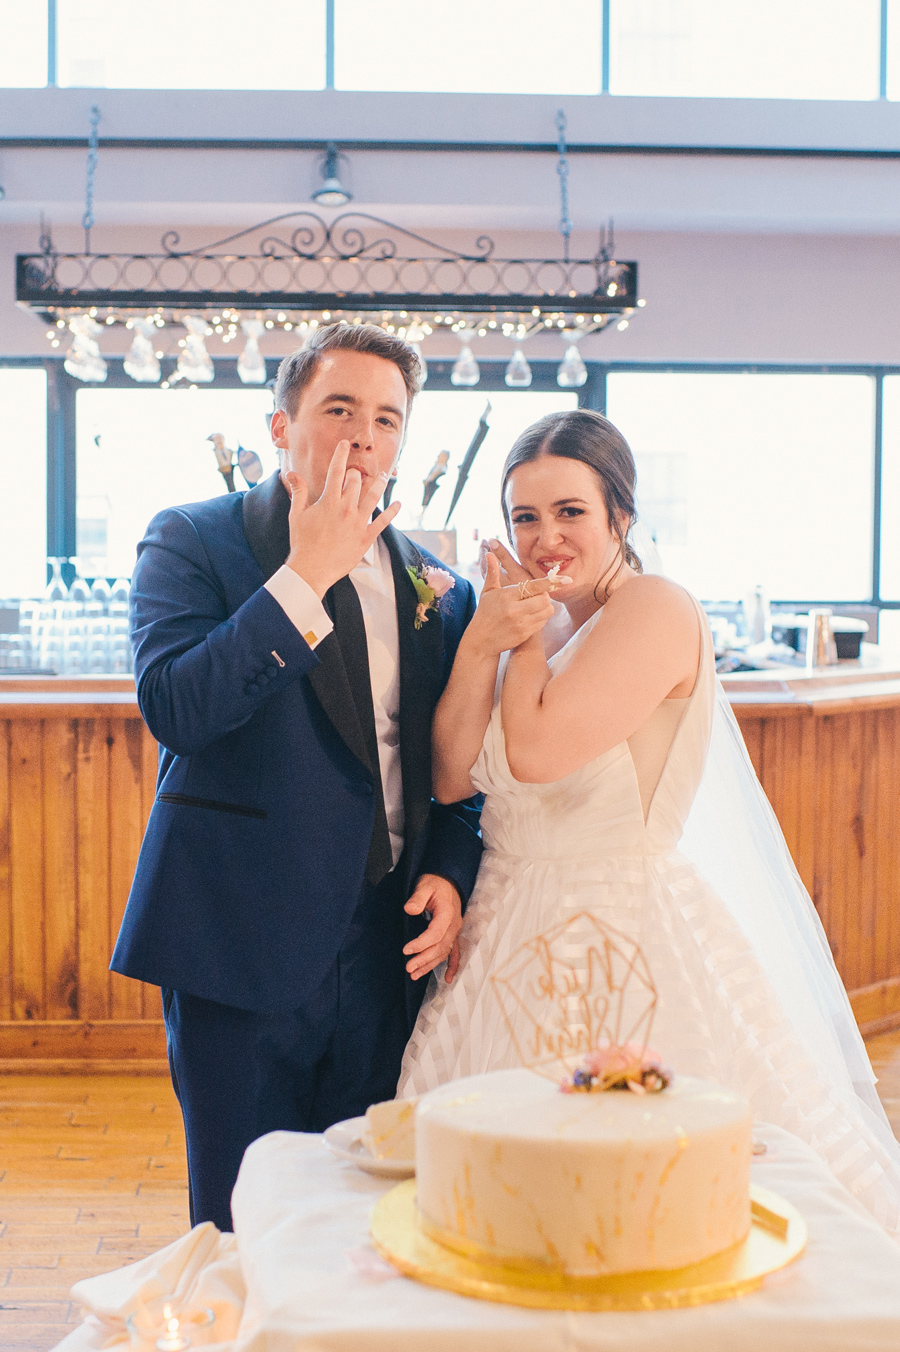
[266,539,404,864]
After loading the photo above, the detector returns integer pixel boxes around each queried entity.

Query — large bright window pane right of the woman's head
[607,373,870,600]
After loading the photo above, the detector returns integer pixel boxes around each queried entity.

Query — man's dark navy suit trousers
[162,871,408,1230]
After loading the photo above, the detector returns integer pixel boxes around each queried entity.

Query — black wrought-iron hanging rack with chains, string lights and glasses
[16,110,643,385]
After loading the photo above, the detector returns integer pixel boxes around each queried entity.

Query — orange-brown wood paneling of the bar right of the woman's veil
[735,700,900,1033]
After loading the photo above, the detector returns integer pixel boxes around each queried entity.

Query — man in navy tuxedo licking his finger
[111,324,481,1230]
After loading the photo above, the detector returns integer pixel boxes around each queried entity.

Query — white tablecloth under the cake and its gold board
[56,1128,900,1352]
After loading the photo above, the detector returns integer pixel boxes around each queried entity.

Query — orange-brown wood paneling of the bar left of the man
[0,696,165,1065]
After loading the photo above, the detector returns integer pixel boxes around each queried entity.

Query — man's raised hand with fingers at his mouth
[282,441,400,599]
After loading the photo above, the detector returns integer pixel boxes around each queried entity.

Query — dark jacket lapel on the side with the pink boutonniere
[381,526,443,841]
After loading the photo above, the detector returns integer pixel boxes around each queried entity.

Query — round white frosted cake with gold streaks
[416,1069,751,1276]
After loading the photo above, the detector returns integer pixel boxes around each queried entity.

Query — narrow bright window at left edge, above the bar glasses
[0,366,47,598]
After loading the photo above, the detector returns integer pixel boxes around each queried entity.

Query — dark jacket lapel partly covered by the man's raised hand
[237,473,370,773]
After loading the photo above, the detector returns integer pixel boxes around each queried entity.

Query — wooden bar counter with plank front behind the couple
[0,645,900,1072]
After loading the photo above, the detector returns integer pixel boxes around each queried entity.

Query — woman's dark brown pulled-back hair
[500,408,643,604]
